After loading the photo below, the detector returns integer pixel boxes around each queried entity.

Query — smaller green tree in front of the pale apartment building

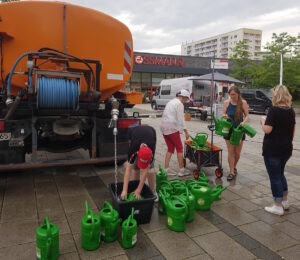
[229,40,255,85]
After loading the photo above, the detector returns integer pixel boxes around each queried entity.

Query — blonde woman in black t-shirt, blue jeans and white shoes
[261,85,296,215]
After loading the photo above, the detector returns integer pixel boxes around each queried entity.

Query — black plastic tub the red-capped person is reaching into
[109,181,155,224]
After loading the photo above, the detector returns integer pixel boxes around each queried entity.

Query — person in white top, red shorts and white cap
[160,89,190,176]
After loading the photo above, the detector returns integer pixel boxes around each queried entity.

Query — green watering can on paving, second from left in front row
[81,200,101,250]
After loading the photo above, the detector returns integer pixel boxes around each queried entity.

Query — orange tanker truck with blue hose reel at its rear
[0,1,140,170]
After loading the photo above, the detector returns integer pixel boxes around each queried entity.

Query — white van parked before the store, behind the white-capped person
[151,77,216,109]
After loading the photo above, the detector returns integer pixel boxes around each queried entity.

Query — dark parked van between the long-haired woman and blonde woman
[240,89,272,114]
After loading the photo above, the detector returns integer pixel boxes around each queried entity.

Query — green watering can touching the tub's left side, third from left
[100,200,122,242]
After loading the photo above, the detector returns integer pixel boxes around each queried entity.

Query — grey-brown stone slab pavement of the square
[0,106,300,260]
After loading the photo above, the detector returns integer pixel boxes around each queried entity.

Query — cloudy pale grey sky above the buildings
[53,0,300,54]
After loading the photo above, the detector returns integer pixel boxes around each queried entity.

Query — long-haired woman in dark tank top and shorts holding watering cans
[223,86,249,181]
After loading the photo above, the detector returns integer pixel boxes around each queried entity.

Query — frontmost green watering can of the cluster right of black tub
[163,196,188,232]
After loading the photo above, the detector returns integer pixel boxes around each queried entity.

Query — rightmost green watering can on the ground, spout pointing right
[190,183,226,210]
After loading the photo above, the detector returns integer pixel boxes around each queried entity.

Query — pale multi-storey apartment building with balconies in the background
[181,28,262,60]
